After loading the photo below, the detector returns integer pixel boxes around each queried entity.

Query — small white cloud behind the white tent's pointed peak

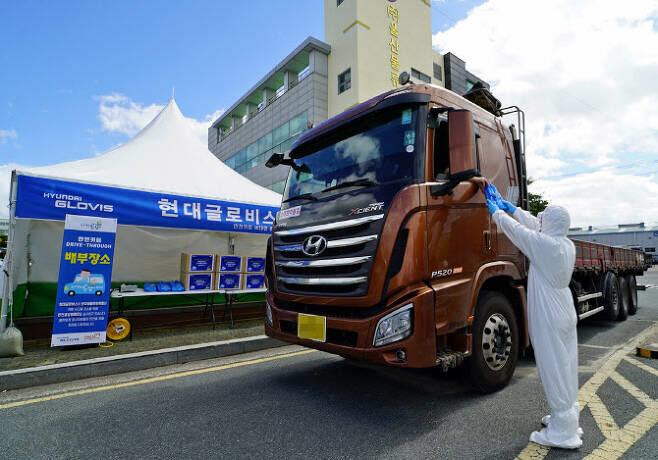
[96,93,224,144]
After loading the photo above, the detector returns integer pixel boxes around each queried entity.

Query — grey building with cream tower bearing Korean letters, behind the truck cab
[208,0,489,193]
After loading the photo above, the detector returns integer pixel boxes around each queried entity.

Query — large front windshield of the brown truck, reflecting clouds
[283,106,418,202]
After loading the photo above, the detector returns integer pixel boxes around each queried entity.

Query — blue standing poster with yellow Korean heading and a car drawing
[50,214,117,347]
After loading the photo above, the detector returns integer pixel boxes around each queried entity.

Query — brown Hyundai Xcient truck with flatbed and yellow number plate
[265,78,646,392]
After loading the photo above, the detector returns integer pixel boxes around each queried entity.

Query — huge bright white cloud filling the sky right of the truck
[432,0,658,225]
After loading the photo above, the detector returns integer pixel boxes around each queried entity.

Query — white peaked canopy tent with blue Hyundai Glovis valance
[3,99,281,326]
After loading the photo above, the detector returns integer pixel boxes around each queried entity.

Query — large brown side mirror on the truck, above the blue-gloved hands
[448,110,480,181]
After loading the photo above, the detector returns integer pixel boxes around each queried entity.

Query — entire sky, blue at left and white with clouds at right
[0,0,658,225]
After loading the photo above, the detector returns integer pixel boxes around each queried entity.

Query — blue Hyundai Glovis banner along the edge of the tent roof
[16,174,279,233]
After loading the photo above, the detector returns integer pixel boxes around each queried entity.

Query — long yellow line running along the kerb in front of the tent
[0,350,316,410]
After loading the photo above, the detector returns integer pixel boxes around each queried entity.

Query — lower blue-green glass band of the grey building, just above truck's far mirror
[225,111,308,175]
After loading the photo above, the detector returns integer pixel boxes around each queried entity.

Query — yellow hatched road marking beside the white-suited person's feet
[516,323,658,460]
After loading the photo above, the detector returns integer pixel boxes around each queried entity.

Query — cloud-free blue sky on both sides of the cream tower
[0,0,481,165]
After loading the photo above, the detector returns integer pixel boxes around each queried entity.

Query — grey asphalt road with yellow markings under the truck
[0,271,658,459]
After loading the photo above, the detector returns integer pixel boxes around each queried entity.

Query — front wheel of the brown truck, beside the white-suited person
[464,292,519,393]
